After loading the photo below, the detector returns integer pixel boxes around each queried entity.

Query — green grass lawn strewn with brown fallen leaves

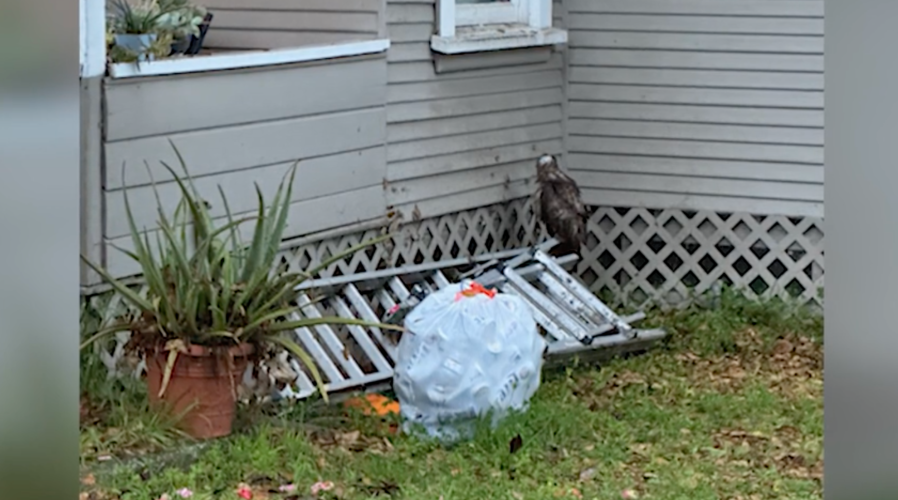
[81,295,823,500]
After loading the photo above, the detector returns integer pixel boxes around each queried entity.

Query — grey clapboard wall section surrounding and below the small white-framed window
[387,0,564,221]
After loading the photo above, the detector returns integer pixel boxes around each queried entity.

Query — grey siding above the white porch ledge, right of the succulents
[204,0,384,49]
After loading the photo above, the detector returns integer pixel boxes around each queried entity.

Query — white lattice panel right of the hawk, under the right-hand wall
[577,207,823,307]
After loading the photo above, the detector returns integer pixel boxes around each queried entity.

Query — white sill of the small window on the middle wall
[430,24,567,55]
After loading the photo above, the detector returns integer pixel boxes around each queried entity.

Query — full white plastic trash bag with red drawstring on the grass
[393,281,546,440]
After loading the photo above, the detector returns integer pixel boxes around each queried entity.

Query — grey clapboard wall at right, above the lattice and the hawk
[565,0,824,217]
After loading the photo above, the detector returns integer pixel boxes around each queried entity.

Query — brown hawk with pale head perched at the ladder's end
[533,154,588,256]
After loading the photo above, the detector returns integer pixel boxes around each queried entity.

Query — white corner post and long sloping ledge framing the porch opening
[79,0,390,78]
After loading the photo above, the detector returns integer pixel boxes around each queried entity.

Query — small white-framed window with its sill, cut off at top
[430,0,567,54]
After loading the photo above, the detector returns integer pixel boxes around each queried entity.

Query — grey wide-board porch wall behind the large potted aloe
[102,55,387,275]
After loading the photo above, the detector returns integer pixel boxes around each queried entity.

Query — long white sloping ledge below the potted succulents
[109,39,390,78]
